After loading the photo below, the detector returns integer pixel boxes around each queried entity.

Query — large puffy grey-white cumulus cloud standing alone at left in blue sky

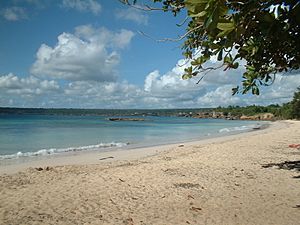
[31,25,134,81]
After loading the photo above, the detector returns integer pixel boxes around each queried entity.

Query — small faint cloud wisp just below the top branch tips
[115,8,149,25]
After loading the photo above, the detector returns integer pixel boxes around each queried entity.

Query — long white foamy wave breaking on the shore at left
[0,142,129,160]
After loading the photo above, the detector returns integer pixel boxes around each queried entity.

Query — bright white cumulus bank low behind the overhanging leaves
[144,57,300,108]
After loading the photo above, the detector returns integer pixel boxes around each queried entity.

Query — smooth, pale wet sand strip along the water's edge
[0,121,272,175]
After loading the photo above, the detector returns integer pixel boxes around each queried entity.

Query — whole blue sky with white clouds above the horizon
[0,0,300,109]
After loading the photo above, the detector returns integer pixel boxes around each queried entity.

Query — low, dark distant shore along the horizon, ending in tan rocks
[0,107,282,121]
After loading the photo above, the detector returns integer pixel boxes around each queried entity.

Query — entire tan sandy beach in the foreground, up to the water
[0,121,300,225]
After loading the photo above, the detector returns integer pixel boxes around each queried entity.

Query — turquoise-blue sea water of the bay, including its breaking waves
[0,115,258,160]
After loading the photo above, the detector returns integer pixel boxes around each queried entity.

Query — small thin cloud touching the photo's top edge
[62,0,101,15]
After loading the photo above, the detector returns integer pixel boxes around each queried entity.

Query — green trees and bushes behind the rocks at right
[216,88,300,120]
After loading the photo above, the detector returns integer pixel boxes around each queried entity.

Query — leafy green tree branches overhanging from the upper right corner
[120,0,300,95]
